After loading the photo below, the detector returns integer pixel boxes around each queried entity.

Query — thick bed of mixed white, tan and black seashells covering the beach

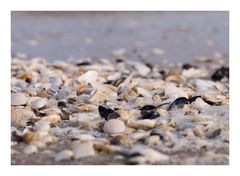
[11,58,229,164]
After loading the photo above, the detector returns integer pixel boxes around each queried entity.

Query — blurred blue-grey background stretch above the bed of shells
[11,11,229,63]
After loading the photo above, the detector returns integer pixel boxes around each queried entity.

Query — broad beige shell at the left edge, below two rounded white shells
[11,109,36,127]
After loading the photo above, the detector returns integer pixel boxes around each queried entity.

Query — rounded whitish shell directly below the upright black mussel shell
[103,119,125,134]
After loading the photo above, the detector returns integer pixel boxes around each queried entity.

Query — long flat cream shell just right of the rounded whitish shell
[127,119,156,130]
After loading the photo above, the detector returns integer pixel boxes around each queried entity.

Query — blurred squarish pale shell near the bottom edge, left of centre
[72,141,95,159]
